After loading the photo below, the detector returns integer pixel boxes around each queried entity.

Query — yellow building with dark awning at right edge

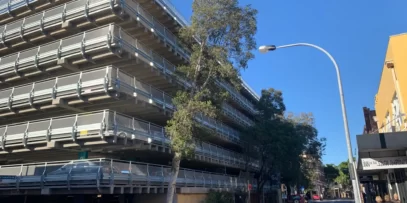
[357,34,407,203]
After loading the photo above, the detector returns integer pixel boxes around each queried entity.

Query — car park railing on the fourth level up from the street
[0,25,244,140]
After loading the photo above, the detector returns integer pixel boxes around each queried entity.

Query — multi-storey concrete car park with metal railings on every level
[0,0,270,202]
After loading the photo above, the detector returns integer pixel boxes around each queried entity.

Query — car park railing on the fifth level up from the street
[0,0,190,60]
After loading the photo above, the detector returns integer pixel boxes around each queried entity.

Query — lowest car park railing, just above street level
[0,158,270,192]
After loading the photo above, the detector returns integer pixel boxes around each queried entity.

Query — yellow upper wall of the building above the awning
[375,34,407,130]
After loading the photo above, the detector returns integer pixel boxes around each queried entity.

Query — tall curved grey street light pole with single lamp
[259,43,361,203]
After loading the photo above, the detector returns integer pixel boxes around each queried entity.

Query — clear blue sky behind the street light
[172,0,407,164]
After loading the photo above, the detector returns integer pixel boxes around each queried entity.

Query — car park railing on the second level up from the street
[0,107,249,168]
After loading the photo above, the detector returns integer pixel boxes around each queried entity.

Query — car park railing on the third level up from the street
[0,67,239,142]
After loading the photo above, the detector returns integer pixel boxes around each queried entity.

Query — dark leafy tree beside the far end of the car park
[242,88,325,198]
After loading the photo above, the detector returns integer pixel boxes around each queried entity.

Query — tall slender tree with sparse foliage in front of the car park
[166,0,257,202]
